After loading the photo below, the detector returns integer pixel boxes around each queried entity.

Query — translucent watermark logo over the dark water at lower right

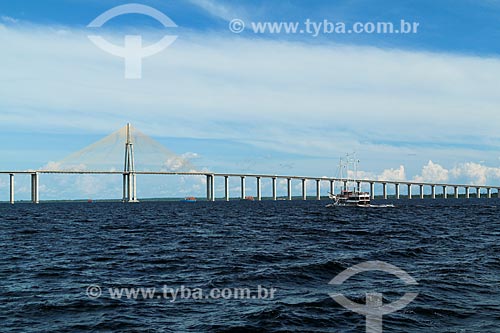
[329,261,418,333]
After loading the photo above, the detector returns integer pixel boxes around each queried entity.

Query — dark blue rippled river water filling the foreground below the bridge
[0,199,500,333]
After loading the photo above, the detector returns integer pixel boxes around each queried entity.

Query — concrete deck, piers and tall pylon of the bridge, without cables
[0,124,500,204]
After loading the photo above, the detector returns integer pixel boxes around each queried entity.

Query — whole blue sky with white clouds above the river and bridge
[0,0,500,201]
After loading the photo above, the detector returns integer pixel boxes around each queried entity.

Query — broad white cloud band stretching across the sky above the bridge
[0,23,500,184]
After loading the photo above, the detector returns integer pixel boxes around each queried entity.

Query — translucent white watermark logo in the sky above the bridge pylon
[87,4,177,79]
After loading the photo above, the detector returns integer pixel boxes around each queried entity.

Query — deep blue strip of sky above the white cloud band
[0,0,500,55]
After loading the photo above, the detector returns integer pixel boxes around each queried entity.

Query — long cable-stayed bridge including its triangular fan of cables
[0,124,500,204]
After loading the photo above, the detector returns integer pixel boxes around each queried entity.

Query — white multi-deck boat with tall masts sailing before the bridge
[326,154,394,207]
